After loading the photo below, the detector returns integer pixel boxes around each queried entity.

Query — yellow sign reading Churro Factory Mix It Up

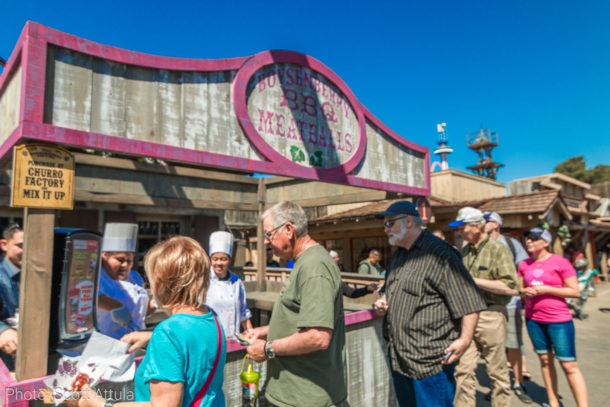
[11,144,74,209]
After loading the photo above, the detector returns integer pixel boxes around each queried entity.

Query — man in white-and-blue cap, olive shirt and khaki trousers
[449,207,519,407]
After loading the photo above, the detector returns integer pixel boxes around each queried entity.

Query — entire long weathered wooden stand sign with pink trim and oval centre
[0,22,430,196]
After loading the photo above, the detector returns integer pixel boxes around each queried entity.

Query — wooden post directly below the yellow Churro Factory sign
[15,208,55,381]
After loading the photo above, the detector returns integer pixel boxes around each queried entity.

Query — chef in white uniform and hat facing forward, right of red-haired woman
[206,232,252,336]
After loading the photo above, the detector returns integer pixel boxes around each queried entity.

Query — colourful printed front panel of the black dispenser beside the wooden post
[62,234,100,336]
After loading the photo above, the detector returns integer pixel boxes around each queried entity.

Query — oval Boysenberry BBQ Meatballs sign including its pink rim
[233,51,366,175]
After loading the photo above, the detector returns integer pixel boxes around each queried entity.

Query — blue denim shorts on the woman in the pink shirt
[525,319,576,362]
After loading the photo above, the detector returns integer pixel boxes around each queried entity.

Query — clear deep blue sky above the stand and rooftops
[0,0,610,182]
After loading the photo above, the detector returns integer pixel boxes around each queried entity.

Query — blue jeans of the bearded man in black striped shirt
[390,360,455,407]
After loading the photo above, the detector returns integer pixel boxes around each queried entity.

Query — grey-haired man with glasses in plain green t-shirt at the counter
[248,202,347,407]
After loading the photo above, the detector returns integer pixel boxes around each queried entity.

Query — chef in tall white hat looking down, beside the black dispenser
[97,223,154,339]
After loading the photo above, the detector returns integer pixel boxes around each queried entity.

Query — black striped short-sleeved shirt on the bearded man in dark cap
[384,230,485,380]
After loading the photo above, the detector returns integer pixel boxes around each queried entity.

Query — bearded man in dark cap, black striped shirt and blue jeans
[375,201,485,407]
